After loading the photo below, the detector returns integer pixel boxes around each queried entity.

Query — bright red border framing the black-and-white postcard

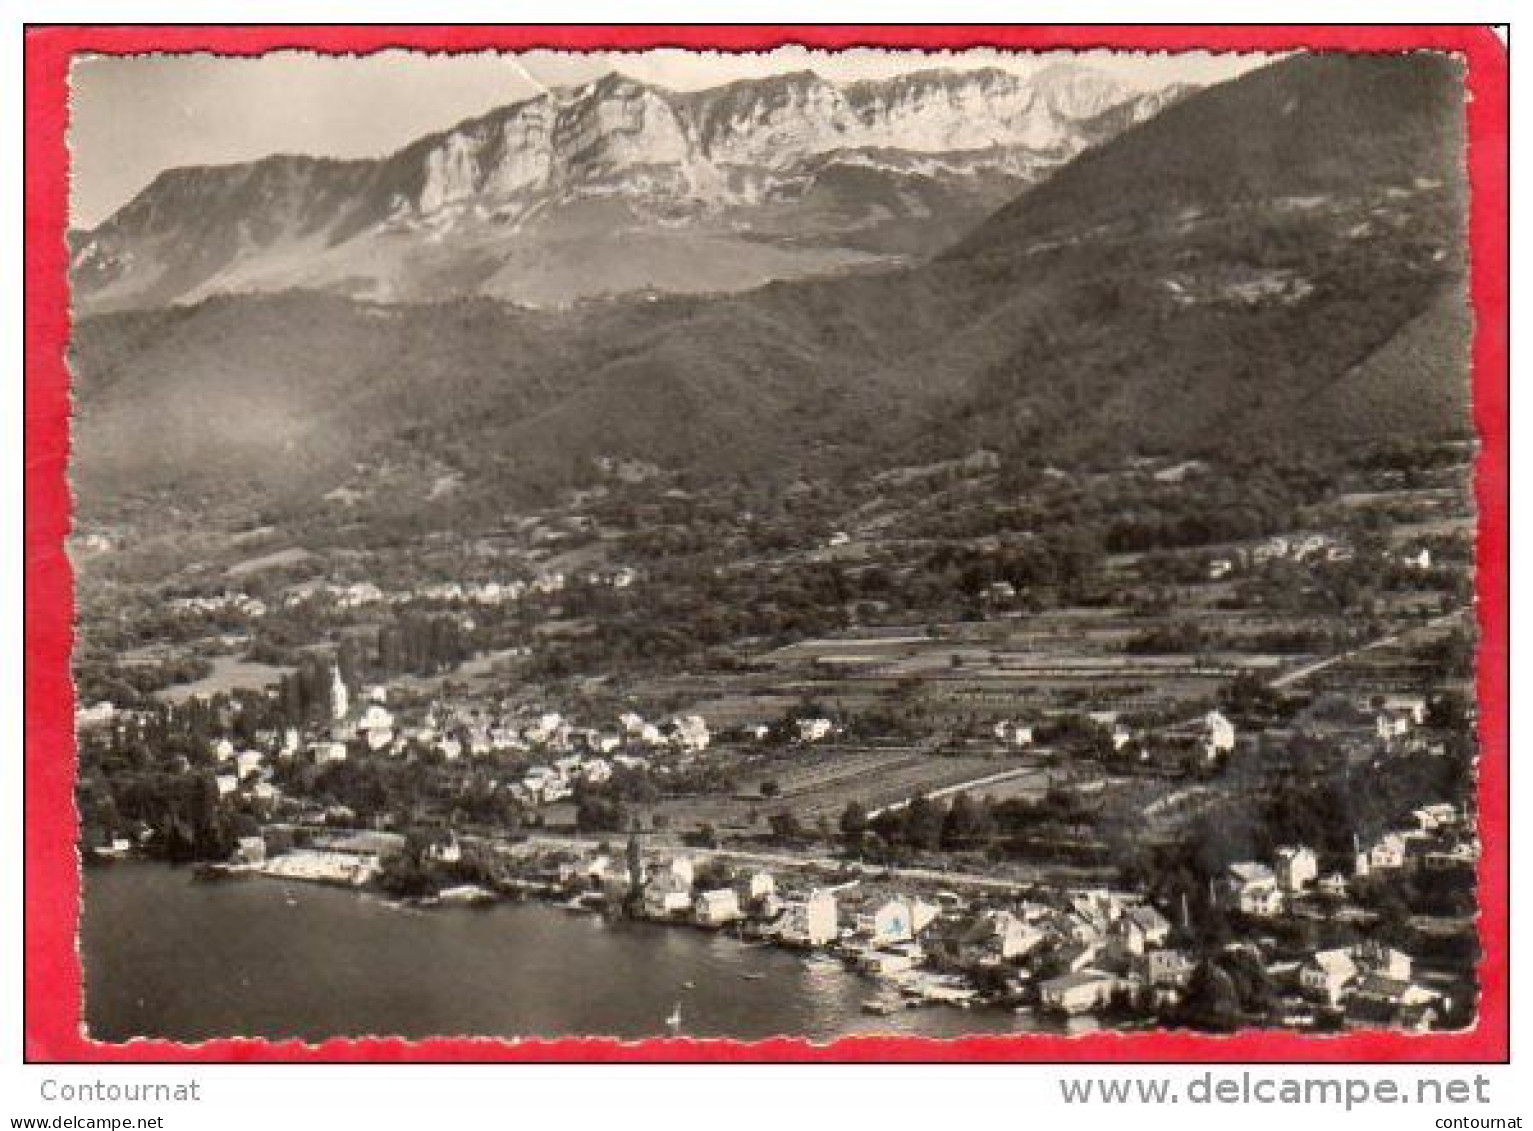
[25,25,1510,1064]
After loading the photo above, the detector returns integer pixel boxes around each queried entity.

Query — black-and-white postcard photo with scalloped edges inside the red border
[67,46,1484,1048]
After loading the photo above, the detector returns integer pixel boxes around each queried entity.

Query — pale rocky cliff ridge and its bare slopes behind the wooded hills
[74,66,1182,311]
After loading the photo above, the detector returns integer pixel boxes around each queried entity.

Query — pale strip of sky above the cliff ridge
[69,48,1268,228]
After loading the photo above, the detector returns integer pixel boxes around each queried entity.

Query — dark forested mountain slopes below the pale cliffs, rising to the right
[72,54,1470,518]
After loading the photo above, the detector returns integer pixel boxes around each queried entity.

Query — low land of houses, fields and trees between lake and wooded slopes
[77,435,1479,1031]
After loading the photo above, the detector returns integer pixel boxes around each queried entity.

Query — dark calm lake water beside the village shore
[81,863,1091,1042]
